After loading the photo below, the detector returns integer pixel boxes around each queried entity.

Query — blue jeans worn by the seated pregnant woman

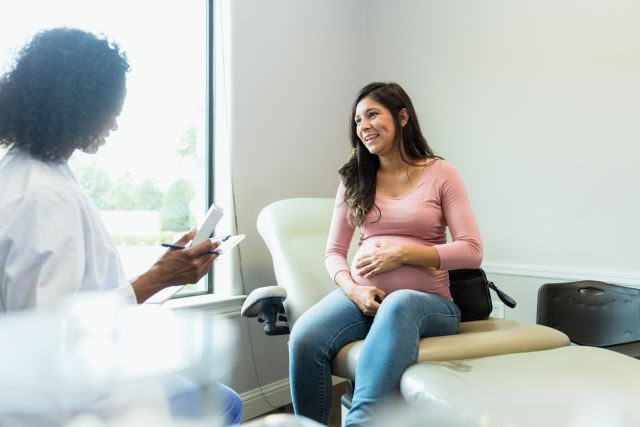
[289,289,460,426]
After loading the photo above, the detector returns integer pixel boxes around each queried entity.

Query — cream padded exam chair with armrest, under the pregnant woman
[241,198,580,425]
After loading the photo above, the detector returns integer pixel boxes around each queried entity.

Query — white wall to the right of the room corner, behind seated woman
[364,0,640,321]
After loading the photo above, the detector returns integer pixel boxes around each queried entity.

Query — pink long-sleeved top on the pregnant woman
[325,160,482,300]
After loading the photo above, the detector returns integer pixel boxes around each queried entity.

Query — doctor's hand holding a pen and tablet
[131,229,220,303]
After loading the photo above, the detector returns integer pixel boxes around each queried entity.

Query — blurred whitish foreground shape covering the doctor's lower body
[0,292,235,427]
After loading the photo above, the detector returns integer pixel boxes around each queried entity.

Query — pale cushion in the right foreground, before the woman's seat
[400,346,640,427]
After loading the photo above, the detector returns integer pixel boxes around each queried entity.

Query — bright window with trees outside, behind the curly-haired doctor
[0,0,220,295]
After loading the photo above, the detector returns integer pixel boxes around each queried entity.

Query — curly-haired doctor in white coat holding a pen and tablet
[0,28,242,422]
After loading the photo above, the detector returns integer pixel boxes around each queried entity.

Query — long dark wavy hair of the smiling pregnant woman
[338,82,437,226]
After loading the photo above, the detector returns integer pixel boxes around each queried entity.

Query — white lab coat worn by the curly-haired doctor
[0,148,135,313]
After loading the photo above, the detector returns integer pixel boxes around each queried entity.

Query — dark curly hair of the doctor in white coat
[0,28,130,161]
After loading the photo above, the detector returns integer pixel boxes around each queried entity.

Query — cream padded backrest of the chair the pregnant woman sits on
[257,198,359,328]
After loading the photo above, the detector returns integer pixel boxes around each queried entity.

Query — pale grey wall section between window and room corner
[229,0,364,414]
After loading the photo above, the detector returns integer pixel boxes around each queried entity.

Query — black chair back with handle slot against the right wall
[536,280,640,358]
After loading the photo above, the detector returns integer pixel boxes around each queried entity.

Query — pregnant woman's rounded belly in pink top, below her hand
[351,236,451,300]
